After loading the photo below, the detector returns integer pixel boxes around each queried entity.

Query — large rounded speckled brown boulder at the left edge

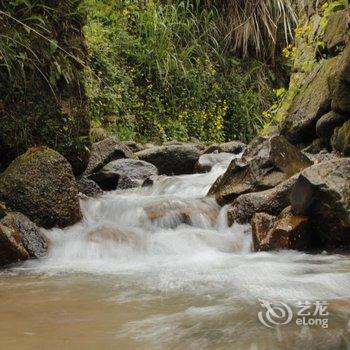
[0,147,82,228]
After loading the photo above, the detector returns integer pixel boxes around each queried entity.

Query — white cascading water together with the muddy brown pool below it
[0,156,350,349]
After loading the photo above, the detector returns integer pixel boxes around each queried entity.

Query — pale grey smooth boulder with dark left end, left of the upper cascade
[90,159,158,191]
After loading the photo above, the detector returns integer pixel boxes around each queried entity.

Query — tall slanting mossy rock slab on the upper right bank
[281,57,340,144]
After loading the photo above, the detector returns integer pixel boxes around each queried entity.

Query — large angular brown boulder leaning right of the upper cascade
[208,136,312,204]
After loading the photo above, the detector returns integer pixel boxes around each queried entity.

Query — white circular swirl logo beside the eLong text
[258,299,293,328]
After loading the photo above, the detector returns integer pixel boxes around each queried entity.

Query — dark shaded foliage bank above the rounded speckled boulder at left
[0,0,89,172]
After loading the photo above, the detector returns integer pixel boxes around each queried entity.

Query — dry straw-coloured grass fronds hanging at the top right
[205,0,298,60]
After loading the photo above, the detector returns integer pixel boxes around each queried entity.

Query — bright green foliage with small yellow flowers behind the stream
[85,0,272,142]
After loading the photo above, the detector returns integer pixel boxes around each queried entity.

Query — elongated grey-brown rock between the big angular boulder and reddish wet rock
[227,175,299,226]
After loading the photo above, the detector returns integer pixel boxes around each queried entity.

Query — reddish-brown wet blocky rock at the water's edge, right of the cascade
[251,208,311,251]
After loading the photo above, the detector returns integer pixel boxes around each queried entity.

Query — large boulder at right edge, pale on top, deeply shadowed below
[291,158,350,247]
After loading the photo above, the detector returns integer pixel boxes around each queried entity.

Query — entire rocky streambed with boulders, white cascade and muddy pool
[0,136,350,349]
